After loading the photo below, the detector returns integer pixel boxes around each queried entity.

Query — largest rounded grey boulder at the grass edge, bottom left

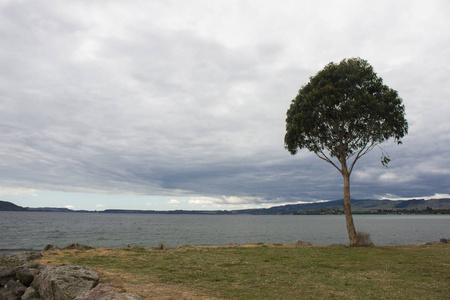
[32,265,99,300]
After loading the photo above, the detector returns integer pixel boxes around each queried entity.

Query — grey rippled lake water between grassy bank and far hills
[0,211,450,253]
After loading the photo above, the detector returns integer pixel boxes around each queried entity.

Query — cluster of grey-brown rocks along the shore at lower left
[0,244,142,300]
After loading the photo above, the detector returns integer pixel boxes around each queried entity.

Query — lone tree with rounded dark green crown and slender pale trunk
[284,58,408,246]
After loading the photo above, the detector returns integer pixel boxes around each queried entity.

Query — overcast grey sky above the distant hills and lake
[0,0,450,210]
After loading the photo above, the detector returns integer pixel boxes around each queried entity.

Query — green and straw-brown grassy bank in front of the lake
[37,244,450,299]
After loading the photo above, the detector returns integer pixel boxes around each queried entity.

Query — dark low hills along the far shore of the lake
[0,198,450,215]
